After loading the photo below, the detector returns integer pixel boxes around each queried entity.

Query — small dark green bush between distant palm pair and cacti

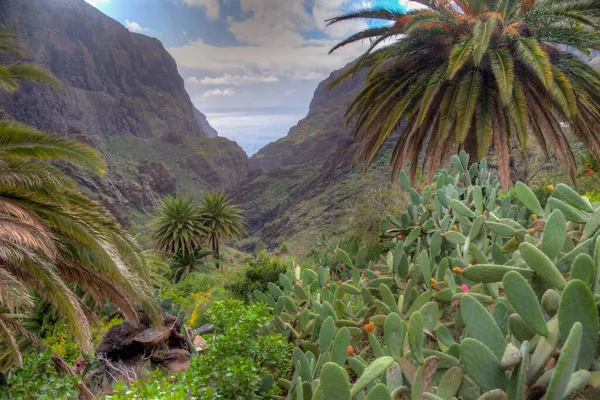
[225,251,287,299]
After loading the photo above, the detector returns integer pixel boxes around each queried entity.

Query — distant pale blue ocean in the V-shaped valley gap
[204,109,307,156]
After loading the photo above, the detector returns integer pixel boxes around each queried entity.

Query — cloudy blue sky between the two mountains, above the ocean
[86,0,404,113]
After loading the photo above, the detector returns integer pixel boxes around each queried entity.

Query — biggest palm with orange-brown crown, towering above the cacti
[329,0,600,186]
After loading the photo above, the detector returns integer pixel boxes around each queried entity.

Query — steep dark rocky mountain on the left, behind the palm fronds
[0,0,248,222]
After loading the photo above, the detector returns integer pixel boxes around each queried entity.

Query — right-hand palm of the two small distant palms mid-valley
[200,191,246,269]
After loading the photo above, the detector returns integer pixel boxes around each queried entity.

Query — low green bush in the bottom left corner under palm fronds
[0,350,79,400]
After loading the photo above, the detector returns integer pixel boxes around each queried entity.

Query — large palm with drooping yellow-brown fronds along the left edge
[0,32,160,369]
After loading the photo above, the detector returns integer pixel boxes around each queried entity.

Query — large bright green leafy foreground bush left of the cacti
[108,300,291,400]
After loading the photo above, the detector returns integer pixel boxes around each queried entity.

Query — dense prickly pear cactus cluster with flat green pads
[255,152,600,400]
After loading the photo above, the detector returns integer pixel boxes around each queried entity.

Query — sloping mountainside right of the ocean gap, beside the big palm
[234,66,404,253]
